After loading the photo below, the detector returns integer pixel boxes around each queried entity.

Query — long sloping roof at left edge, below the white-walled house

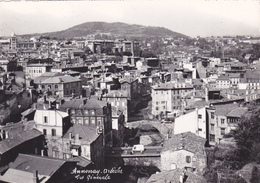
[0,129,42,154]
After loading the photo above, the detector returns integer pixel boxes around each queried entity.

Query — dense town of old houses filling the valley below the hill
[0,20,260,183]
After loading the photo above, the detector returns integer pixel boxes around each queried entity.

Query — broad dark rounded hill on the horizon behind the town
[35,22,187,38]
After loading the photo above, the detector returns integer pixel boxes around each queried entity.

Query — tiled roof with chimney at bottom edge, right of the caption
[146,169,206,183]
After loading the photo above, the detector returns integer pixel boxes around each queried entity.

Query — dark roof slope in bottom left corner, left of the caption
[9,154,69,176]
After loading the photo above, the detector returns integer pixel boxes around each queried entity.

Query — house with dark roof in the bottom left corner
[0,154,77,183]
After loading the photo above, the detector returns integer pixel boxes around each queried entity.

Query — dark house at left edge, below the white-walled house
[0,129,45,167]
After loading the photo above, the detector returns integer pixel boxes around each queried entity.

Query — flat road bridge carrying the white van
[105,146,162,158]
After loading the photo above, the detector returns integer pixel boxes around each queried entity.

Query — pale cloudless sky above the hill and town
[0,0,260,37]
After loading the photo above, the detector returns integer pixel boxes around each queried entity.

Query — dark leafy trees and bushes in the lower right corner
[204,103,260,183]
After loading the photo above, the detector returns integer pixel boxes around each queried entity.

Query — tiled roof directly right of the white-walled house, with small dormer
[64,124,99,144]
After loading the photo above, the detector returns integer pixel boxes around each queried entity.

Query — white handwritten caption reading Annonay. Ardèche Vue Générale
[71,167,123,181]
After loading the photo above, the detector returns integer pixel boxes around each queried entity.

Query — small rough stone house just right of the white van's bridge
[161,132,207,173]
